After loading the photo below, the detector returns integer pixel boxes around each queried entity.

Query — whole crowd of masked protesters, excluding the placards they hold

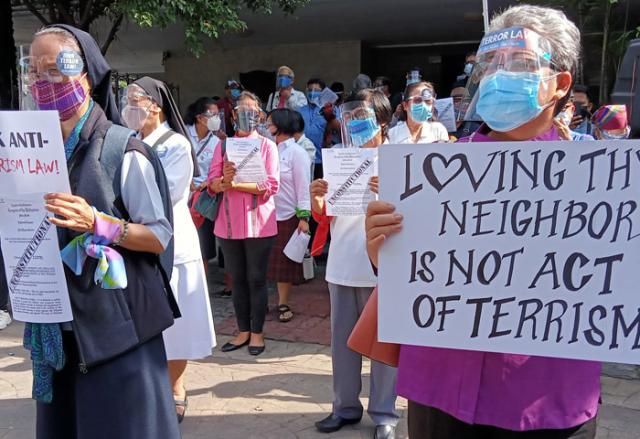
[0,5,630,439]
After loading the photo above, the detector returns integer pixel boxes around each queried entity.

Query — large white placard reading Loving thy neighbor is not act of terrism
[379,140,640,364]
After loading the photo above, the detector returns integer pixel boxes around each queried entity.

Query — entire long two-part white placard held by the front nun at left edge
[0,111,72,323]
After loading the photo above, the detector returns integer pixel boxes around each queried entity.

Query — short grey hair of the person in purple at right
[489,5,580,75]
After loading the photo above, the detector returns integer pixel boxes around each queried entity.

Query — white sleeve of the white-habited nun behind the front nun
[159,134,193,206]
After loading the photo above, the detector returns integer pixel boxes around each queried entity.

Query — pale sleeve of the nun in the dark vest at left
[120,151,173,248]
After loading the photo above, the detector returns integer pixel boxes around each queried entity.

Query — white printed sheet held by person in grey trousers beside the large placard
[322,148,378,216]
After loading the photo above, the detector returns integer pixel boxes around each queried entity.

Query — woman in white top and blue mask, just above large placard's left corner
[389,81,449,144]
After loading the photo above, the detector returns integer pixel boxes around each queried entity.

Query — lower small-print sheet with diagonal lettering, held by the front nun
[0,194,72,323]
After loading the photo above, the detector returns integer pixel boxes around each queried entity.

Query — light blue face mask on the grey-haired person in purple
[476,70,551,133]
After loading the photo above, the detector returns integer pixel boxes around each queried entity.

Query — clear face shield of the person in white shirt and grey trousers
[340,101,381,148]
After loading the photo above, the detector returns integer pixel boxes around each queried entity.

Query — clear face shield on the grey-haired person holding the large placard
[459,27,556,132]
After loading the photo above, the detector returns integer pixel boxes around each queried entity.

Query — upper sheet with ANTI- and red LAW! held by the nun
[0,111,70,196]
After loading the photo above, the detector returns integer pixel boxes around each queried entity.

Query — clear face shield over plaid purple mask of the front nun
[18,43,88,121]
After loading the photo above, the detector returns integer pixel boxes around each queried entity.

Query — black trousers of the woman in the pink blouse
[220,236,276,334]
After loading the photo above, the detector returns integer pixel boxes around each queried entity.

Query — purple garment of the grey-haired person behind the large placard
[398,125,601,431]
